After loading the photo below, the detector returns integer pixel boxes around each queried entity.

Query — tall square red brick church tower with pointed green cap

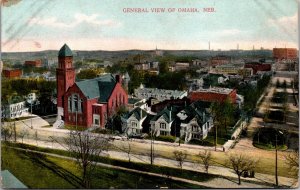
[56,44,75,119]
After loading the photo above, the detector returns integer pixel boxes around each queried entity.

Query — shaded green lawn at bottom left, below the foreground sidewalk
[1,145,204,189]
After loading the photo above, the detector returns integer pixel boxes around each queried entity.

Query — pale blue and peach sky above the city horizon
[1,0,298,52]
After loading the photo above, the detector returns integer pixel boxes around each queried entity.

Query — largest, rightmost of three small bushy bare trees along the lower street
[229,154,258,185]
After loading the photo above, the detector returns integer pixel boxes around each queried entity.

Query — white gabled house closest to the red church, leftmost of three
[122,107,147,136]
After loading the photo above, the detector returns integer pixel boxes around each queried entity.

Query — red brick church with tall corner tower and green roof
[54,44,128,128]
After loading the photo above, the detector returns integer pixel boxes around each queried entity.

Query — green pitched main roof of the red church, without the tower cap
[75,74,116,102]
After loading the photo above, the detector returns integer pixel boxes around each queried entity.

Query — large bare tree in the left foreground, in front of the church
[64,131,109,188]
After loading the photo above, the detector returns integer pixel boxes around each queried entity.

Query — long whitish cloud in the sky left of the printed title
[28,14,120,28]
